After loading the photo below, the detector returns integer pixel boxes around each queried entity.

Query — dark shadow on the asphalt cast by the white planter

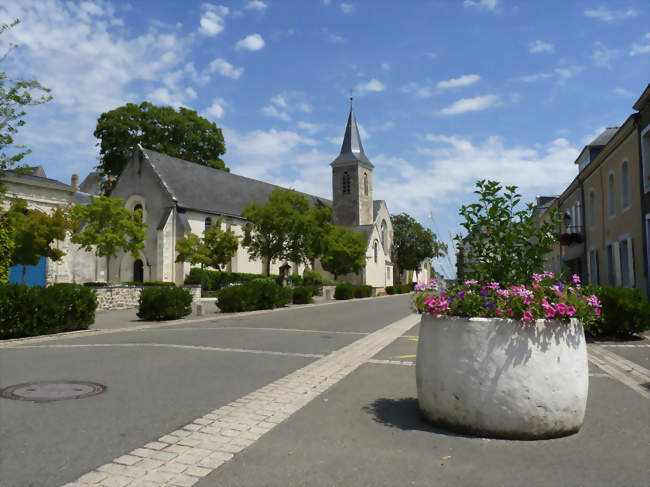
[362,397,474,438]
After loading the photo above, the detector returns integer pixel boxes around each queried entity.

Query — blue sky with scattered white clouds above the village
[0,0,650,277]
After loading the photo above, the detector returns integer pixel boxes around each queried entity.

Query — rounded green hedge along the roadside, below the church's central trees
[217,278,292,313]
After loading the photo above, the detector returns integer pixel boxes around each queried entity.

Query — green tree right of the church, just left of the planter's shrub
[391,213,447,283]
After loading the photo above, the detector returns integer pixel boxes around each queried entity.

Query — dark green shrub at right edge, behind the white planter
[585,286,650,337]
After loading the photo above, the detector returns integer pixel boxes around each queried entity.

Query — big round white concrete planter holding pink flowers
[416,314,589,439]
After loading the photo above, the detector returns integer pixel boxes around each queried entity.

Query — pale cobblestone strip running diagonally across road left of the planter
[65,315,420,487]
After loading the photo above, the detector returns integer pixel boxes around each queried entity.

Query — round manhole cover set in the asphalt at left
[0,380,106,402]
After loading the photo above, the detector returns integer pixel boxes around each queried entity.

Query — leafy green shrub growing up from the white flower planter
[456,180,560,285]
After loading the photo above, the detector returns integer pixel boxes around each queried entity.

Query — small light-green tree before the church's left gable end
[71,196,147,282]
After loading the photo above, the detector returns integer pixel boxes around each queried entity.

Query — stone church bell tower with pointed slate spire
[330,97,374,227]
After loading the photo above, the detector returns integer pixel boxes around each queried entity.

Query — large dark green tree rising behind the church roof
[94,101,228,176]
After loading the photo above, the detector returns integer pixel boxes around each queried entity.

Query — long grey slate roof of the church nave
[142,149,332,216]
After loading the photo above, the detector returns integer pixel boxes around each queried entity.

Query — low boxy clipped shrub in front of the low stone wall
[138,286,192,321]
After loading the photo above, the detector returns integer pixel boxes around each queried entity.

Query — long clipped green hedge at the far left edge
[0,284,97,339]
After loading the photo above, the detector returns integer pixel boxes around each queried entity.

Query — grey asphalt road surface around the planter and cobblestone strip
[0,296,650,487]
